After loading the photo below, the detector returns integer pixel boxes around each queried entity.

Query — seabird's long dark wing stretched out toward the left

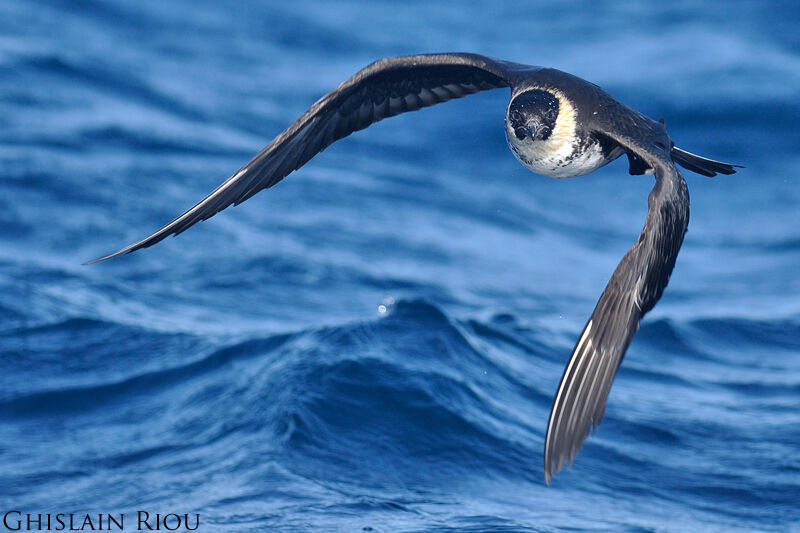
[89,53,520,263]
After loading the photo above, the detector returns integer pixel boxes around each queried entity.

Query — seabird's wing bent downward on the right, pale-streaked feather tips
[544,108,689,484]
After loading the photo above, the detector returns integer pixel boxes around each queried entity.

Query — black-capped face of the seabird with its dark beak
[506,89,559,143]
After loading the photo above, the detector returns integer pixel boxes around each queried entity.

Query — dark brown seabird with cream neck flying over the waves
[90,53,738,484]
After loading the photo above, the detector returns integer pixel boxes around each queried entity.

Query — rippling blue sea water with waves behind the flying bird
[0,0,800,532]
